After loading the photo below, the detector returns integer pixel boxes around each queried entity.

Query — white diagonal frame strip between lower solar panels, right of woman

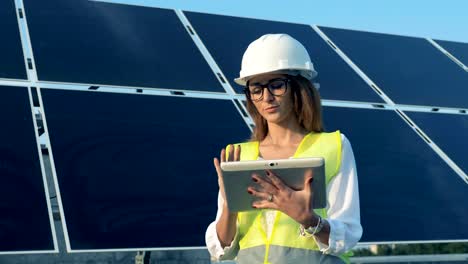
[395,109,468,184]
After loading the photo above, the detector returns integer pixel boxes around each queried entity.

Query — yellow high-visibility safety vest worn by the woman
[226,131,347,264]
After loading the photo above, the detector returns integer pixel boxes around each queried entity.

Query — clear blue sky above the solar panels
[97,0,468,43]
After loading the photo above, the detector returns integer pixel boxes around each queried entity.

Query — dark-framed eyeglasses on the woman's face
[244,78,290,101]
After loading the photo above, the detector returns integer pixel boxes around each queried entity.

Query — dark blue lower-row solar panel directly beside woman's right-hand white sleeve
[324,107,468,242]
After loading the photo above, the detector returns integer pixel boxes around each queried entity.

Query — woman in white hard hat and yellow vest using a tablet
[206,34,362,263]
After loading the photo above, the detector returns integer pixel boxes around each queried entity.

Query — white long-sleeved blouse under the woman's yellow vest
[205,134,362,260]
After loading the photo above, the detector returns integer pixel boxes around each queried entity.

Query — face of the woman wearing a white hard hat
[248,74,294,124]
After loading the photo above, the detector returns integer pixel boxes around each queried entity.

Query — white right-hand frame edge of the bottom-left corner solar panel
[28,87,59,253]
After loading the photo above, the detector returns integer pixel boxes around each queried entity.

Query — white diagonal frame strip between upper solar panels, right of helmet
[311,25,395,105]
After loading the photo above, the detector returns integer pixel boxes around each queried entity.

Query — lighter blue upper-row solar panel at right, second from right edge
[320,27,468,108]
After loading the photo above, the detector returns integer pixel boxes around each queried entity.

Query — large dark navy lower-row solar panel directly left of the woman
[42,89,250,250]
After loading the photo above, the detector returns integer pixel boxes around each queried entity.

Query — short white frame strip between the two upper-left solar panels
[15,0,37,82]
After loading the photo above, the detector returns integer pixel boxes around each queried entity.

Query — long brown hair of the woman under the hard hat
[247,75,324,141]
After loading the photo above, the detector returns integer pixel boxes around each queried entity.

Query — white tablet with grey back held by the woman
[221,158,327,212]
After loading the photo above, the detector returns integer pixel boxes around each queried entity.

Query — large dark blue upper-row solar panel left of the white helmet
[25,0,224,92]
